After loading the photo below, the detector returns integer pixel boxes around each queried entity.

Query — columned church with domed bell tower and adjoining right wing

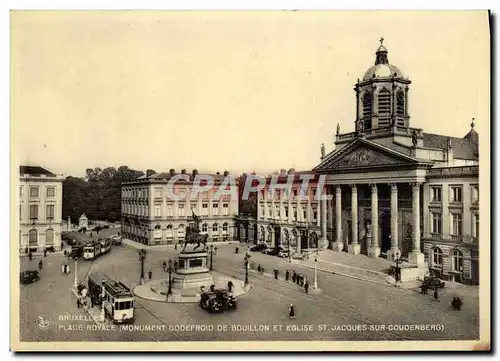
[313,40,479,283]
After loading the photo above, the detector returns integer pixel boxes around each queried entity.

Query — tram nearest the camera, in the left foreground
[88,272,135,323]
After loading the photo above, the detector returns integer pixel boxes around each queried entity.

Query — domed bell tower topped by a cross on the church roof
[354,38,411,134]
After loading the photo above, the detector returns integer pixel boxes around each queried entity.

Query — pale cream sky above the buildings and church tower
[10,11,490,176]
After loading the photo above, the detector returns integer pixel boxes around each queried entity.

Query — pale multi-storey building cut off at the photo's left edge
[19,166,63,253]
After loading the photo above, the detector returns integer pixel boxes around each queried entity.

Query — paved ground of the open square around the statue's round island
[21,245,479,341]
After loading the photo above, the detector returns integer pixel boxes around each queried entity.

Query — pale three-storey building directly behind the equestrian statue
[121,169,238,245]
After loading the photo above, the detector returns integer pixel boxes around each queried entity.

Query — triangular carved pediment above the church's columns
[315,140,418,171]
